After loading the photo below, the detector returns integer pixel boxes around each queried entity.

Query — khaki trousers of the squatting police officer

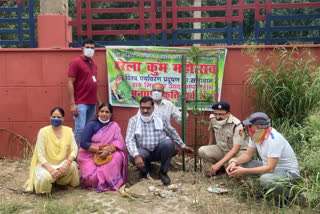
[198,145,245,168]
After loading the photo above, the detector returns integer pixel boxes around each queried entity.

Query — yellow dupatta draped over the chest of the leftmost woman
[24,125,73,192]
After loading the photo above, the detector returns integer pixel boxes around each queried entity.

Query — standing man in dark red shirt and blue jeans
[68,39,101,147]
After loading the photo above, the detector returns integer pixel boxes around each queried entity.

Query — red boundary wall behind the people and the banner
[0,46,320,157]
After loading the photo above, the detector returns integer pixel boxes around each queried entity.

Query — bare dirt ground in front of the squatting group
[0,158,306,214]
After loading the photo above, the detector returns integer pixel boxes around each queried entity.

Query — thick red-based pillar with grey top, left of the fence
[37,0,72,48]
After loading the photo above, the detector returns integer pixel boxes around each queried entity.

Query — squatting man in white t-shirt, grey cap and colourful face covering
[226,112,300,205]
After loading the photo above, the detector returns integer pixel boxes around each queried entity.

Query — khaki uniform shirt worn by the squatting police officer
[208,114,247,153]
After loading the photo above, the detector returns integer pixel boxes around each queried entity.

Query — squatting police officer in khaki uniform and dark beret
[198,102,247,176]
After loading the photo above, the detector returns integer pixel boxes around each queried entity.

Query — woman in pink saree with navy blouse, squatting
[78,103,128,192]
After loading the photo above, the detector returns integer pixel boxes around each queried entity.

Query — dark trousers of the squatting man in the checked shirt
[129,139,175,175]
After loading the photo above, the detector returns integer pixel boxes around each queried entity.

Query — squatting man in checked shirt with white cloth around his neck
[126,97,193,185]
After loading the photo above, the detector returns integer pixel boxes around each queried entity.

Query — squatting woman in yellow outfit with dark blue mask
[24,107,79,193]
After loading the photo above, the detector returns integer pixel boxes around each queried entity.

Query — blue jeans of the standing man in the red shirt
[73,104,96,148]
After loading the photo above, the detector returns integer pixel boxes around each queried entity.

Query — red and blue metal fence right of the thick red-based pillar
[71,0,320,46]
